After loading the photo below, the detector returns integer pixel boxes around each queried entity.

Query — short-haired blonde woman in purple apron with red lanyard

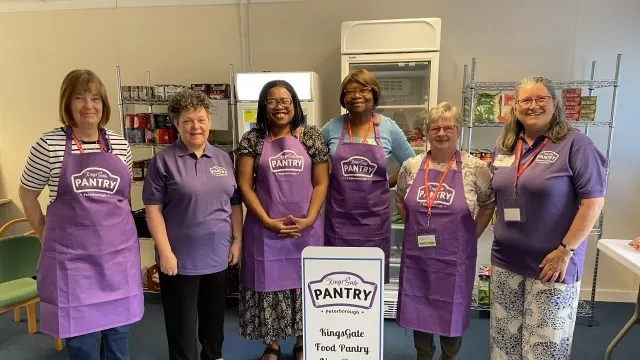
[396,102,495,360]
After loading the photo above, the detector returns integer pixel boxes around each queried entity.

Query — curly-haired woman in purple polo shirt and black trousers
[143,89,242,360]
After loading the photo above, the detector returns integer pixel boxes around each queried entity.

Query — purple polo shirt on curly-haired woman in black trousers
[142,140,241,275]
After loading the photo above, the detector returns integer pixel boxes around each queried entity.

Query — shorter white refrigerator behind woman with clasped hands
[235,71,325,139]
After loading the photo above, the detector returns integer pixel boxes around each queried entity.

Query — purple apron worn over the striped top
[38,127,143,338]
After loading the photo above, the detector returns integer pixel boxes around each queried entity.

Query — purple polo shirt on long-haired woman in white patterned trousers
[491,131,606,283]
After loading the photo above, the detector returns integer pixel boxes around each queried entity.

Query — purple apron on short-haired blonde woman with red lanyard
[396,152,478,336]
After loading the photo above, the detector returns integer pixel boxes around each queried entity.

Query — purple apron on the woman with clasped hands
[241,131,324,292]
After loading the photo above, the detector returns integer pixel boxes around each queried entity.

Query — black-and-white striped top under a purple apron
[20,127,131,203]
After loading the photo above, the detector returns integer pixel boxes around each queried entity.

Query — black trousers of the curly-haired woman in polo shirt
[160,271,226,360]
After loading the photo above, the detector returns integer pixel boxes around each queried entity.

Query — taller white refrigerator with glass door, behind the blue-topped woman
[341,18,441,318]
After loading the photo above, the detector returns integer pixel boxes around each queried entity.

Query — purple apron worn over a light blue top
[325,117,391,282]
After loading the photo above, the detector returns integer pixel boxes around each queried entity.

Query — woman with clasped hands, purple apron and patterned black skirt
[236,80,329,360]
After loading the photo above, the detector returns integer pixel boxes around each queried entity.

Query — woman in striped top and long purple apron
[20,70,143,360]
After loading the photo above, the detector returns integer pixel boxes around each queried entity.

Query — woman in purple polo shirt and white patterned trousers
[491,77,605,360]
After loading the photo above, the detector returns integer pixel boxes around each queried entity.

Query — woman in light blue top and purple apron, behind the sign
[321,70,416,281]
